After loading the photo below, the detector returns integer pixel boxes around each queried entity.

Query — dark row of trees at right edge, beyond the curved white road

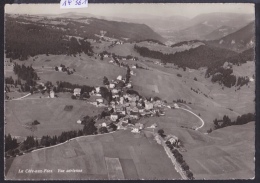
[213,113,255,131]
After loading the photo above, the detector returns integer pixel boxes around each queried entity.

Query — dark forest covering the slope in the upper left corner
[5,17,93,60]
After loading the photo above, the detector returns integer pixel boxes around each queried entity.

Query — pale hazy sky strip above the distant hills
[5,3,254,18]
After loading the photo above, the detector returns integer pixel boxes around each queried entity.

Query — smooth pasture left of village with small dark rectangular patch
[5,96,102,137]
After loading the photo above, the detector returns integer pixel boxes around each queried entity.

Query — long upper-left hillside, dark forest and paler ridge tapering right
[5,15,163,60]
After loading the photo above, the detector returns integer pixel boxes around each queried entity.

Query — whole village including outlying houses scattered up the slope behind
[40,50,182,142]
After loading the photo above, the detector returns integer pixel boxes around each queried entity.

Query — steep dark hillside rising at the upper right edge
[209,22,255,52]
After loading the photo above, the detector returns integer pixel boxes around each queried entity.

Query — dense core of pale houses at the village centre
[92,75,170,133]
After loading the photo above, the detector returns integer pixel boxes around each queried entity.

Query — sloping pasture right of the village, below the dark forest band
[128,62,255,132]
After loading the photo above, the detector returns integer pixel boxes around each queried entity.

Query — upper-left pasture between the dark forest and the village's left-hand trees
[12,54,126,86]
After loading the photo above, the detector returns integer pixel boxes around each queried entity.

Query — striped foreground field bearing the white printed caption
[6,131,181,180]
